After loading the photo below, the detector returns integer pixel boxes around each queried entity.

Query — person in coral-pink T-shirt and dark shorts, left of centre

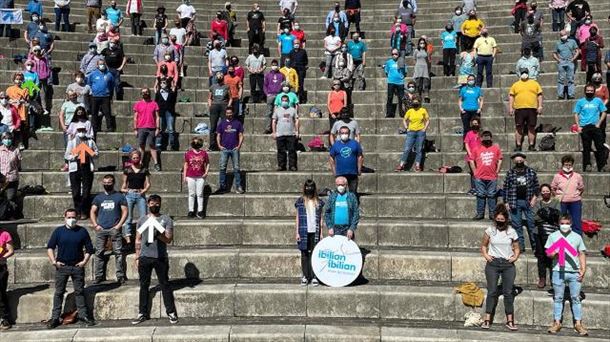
[133,88,161,171]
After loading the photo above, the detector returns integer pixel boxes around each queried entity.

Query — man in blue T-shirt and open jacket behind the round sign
[324,176,360,240]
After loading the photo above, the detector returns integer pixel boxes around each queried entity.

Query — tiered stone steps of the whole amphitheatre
[0,0,610,341]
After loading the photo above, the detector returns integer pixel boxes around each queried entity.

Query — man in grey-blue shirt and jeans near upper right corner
[553,30,580,100]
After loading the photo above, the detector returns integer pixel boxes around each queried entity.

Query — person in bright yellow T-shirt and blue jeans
[394,97,430,172]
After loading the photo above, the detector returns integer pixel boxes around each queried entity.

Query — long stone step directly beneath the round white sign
[9,282,610,329]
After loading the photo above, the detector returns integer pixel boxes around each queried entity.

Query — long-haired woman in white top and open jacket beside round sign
[294,179,324,286]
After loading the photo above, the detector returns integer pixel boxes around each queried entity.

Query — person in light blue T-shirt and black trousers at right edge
[573,84,608,172]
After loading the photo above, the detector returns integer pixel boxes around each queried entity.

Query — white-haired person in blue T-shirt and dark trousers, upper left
[86,59,116,136]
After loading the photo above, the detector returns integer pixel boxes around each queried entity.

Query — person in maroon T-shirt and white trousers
[182,137,210,219]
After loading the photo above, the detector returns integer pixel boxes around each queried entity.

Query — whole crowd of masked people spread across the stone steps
[0,0,610,335]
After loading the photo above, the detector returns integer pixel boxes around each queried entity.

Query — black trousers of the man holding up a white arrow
[138,257,176,317]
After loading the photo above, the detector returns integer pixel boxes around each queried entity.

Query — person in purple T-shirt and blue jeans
[216,107,244,194]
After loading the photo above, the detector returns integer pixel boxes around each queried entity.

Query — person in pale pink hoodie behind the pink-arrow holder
[551,154,585,235]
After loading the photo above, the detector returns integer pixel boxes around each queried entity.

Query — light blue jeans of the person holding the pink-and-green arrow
[552,271,582,321]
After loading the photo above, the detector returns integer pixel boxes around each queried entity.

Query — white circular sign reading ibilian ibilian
[311,235,362,287]
